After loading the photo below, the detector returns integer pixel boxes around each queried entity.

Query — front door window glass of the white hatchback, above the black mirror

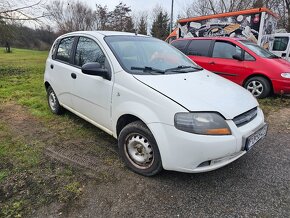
[75,37,105,67]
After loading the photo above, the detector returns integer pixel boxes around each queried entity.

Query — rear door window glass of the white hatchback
[55,37,74,63]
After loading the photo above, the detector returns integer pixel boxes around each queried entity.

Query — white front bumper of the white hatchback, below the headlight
[148,109,264,173]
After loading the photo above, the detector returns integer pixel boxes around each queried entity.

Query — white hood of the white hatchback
[134,70,258,119]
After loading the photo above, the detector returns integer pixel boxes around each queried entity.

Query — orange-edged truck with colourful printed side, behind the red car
[166,8,290,60]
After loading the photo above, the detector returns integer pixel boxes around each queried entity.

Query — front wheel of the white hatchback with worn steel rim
[118,121,163,176]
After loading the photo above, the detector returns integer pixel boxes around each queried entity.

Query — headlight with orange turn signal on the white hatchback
[174,112,231,135]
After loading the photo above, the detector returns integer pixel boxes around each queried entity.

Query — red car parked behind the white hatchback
[171,37,290,98]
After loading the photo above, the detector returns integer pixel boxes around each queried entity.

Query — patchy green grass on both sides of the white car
[0,48,290,217]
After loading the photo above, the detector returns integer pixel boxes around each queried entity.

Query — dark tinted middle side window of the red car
[187,40,212,56]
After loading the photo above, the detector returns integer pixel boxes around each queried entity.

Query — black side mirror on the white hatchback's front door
[82,62,111,80]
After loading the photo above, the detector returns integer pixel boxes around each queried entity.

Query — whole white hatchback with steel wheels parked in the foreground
[44,31,267,176]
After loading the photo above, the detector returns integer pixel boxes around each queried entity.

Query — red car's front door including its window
[207,40,247,85]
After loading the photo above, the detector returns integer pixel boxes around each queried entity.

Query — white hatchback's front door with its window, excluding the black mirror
[72,37,113,130]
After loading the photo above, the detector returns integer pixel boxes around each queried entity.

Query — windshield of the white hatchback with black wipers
[105,36,202,74]
